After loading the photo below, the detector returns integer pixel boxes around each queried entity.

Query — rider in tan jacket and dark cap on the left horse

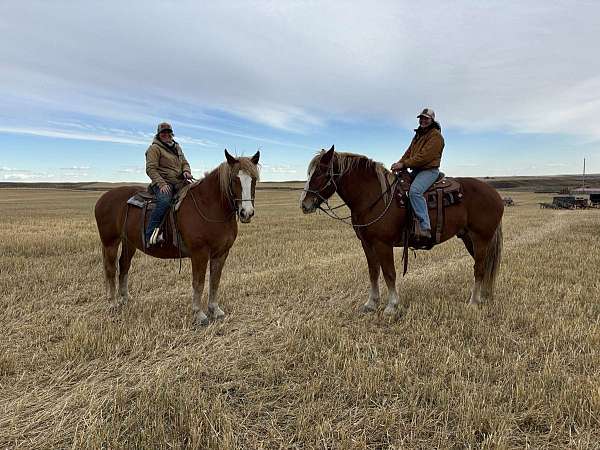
[146,122,192,246]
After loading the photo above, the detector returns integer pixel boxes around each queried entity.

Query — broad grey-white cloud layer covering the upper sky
[0,0,600,140]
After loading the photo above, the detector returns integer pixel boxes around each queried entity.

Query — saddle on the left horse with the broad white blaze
[127,189,189,256]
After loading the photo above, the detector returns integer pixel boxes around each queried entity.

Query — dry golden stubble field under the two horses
[0,185,600,449]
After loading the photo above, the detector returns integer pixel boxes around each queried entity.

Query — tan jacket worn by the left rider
[146,137,191,187]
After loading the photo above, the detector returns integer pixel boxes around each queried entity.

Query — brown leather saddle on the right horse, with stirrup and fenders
[395,171,463,250]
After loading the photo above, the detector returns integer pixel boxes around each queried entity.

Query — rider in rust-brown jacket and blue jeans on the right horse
[392,108,444,239]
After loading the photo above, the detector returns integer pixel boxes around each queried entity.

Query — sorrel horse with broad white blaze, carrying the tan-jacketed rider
[95,150,260,325]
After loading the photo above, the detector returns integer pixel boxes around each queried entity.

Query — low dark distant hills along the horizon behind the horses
[0,174,600,193]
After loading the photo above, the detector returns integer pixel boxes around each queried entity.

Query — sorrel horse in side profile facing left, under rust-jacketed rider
[300,147,504,314]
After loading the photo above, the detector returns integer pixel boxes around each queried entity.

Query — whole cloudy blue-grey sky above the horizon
[0,0,600,182]
